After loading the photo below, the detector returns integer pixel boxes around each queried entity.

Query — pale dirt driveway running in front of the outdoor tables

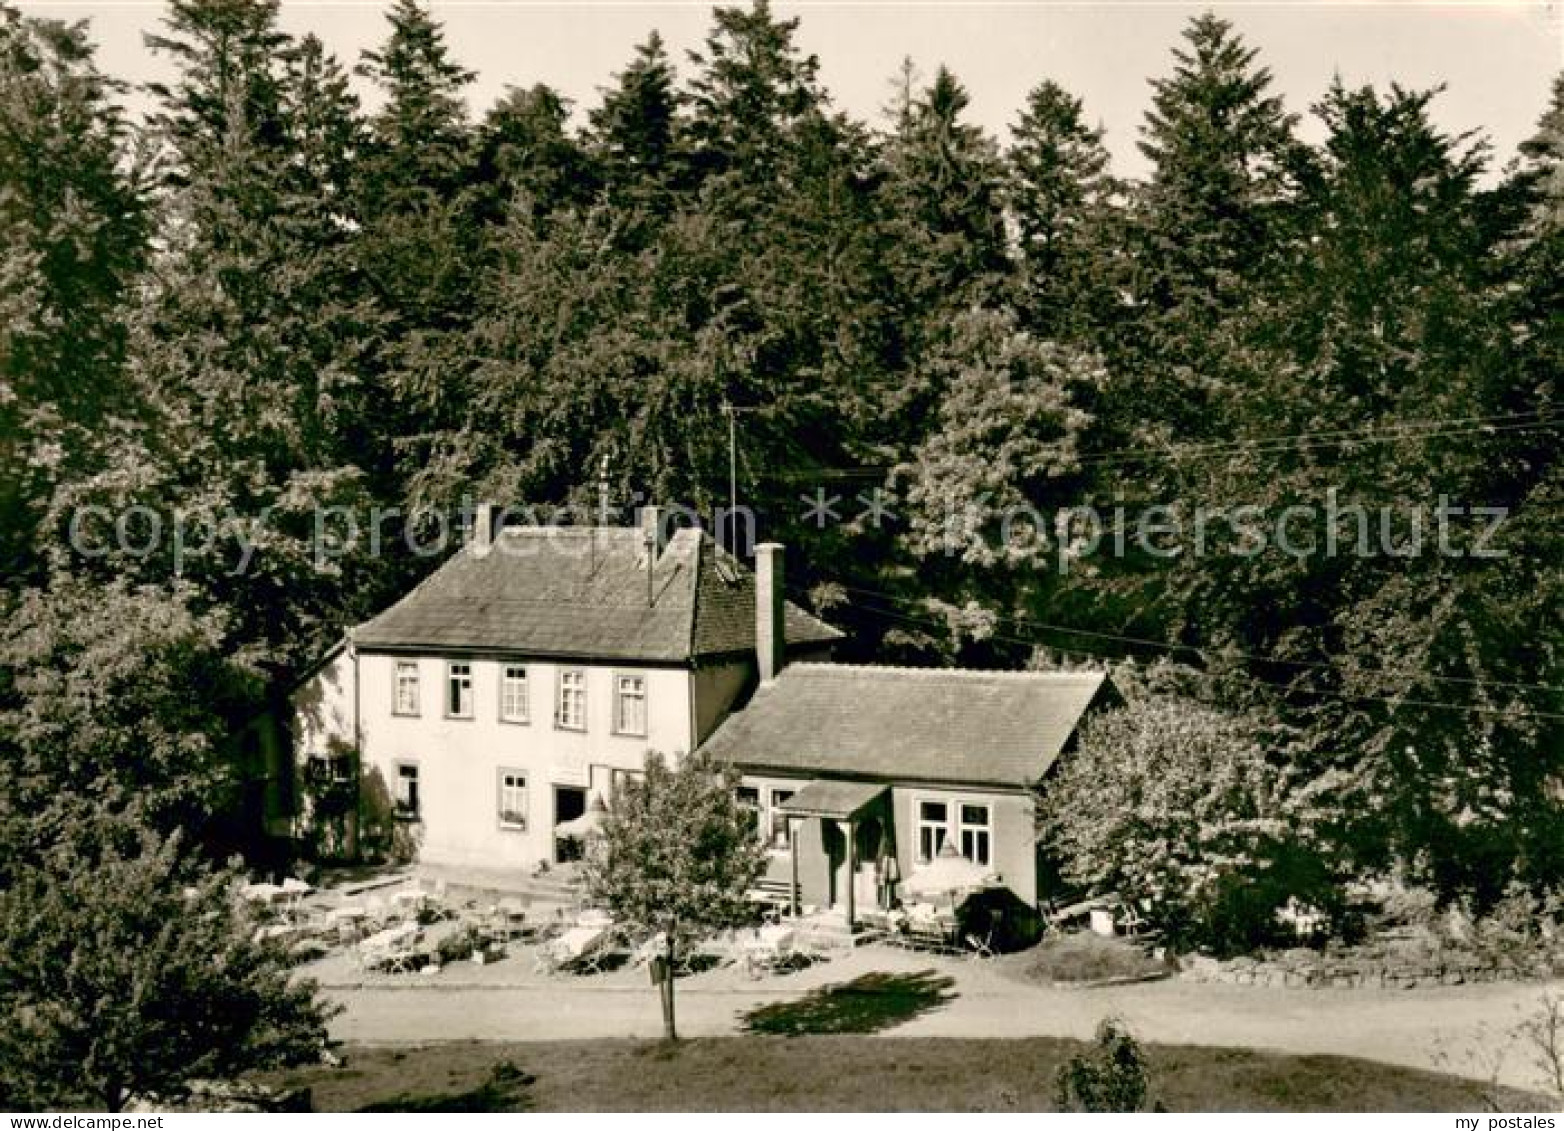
[317,946,1564,1087]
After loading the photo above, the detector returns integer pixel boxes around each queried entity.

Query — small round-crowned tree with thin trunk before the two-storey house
[587,752,765,1040]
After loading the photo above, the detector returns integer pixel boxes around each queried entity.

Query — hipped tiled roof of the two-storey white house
[353,527,841,662]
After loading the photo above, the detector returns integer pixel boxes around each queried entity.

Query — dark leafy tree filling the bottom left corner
[0,813,332,1111]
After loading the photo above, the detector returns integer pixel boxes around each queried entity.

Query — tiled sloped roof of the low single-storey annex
[705,663,1117,787]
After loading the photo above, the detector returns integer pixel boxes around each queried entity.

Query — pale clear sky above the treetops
[20,0,1564,177]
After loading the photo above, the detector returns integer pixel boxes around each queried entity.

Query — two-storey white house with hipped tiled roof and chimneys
[294,508,841,868]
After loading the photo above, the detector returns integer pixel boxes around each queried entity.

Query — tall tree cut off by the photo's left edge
[0,3,149,587]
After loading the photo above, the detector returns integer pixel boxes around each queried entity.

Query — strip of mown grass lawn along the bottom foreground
[267,1034,1547,1111]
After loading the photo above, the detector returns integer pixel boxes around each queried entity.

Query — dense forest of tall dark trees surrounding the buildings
[0,0,1564,926]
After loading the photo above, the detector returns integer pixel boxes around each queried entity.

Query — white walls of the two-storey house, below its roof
[296,644,752,868]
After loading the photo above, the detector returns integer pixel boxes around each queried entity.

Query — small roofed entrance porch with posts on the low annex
[780,781,895,928]
